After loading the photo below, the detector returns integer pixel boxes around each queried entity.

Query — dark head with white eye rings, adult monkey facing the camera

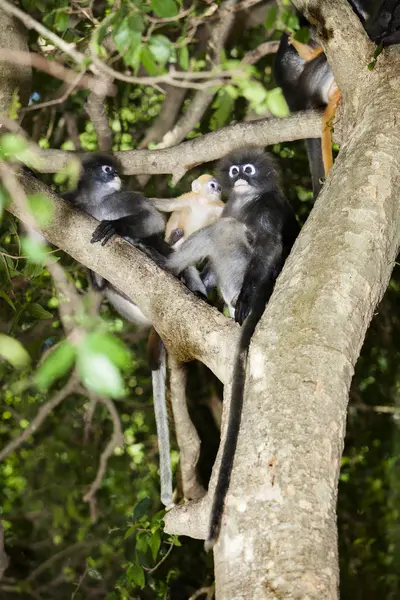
[218,148,277,196]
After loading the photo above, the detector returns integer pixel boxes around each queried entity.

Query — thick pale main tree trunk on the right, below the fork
[214,55,400,600]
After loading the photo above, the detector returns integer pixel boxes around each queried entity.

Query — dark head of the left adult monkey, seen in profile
[78,153,122,195]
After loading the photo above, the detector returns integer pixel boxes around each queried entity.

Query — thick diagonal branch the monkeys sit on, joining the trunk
[9,174,239,381]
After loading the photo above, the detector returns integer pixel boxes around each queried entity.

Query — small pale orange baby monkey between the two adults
[153,174,225,244]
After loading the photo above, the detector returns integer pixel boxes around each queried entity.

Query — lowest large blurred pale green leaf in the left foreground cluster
[76,352,125,398]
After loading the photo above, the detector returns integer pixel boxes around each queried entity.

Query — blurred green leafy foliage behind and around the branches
[0,0,400,600]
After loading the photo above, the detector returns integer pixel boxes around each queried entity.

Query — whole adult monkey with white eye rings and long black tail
[167,149,299,549]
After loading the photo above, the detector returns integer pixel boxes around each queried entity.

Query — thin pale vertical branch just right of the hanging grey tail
[168,354,205,500]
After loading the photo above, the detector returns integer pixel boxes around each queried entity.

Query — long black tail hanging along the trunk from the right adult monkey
[204,277,274,552]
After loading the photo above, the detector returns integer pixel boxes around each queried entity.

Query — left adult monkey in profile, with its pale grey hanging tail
[63,153,205,506]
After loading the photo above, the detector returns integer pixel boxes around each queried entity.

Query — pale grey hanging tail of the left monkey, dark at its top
[148,329,173,506]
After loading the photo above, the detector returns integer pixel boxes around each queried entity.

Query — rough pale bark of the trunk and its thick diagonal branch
[1,0,400,600]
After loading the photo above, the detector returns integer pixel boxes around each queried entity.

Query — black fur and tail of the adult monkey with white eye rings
[205,150,299,549]
